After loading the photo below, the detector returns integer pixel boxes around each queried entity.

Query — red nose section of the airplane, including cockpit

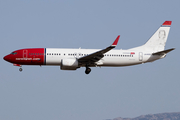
[5,48,45,65]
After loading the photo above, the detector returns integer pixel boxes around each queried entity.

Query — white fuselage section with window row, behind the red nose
[46,48,161,67]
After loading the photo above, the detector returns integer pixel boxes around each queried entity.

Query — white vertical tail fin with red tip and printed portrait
[131,21,172,52]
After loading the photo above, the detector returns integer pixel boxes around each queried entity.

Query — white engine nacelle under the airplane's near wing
[61,59,78,70]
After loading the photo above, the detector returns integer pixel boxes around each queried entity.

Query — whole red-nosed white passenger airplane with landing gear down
[4,21,175,74]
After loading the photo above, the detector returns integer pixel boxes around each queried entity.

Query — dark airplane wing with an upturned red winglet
[78,35,120,65]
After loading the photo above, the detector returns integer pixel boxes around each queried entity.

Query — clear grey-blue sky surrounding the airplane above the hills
[0,0,180,120]
